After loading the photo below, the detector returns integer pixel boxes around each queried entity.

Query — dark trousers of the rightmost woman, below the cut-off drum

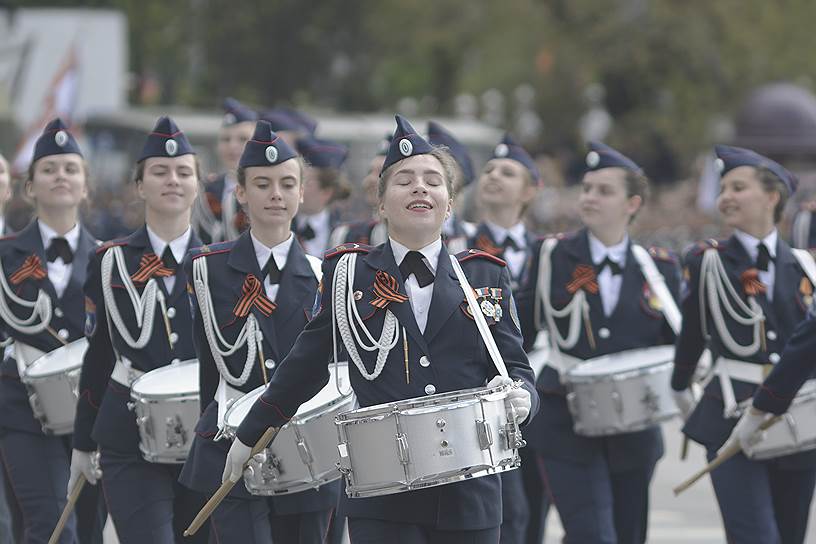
[708,451,816,544]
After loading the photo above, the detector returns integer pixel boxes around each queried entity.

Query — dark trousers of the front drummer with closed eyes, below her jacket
[348,517,500,544]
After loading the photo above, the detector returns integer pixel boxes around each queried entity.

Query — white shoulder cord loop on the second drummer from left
[102,246,164,349]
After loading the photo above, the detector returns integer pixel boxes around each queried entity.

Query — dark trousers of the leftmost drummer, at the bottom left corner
[0,429,105,544]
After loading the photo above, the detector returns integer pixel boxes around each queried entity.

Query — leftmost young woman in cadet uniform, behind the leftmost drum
[0,119,104,544]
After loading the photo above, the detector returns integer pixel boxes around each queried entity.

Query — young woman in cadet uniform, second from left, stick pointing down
[68,117,206,544]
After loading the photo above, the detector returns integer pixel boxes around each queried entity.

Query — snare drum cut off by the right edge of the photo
[745,380,816,460]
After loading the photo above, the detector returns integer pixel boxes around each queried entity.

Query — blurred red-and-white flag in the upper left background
[11,45,79,175]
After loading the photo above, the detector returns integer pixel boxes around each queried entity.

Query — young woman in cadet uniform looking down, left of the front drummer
[181,121,340,544]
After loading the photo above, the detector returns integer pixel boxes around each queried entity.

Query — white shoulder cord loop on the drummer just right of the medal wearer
[534,238,589,350]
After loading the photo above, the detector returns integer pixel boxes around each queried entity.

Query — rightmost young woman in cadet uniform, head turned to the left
[672,145,816,544]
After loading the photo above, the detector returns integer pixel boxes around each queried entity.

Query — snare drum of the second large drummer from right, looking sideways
[564,346,679,436]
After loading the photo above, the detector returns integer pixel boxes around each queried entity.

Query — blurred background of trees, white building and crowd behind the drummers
[0,0,816,249]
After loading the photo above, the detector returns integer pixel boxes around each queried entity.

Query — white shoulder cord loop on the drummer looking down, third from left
[193,257,256,387]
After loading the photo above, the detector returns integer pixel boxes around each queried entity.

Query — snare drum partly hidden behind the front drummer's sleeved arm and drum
[224,363,355,495]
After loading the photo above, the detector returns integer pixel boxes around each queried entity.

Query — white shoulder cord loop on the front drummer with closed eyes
[331,253,399,381]
